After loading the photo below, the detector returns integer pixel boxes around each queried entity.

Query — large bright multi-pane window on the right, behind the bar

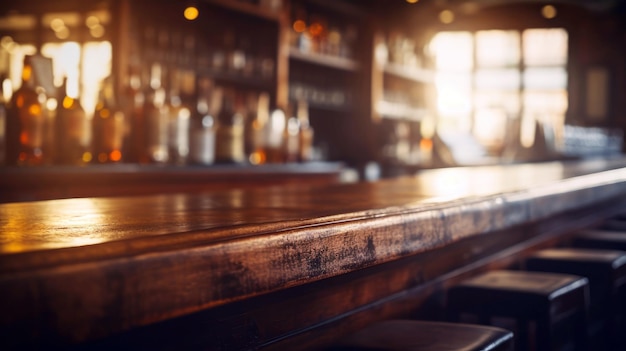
[430,28,568,150]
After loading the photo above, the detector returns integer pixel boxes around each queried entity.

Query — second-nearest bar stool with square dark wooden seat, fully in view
[446,270,589,351]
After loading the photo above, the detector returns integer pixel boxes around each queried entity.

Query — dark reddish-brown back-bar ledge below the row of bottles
[0,162,344,203]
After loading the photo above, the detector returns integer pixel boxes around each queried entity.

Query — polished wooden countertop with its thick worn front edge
[0,159,626,342]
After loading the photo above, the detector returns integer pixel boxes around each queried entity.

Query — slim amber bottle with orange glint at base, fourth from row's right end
[244,92,270,165]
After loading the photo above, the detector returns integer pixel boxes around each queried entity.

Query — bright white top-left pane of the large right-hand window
[430,32,474,71]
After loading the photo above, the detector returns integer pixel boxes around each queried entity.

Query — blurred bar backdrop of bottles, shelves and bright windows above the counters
[0,0,626,180]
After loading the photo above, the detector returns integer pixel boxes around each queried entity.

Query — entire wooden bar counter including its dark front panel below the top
[0,159,626,350]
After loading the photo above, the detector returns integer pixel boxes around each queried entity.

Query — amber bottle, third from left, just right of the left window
[91,77,126,163]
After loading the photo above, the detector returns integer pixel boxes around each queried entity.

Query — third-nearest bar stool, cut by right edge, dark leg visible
[525,248,626,350]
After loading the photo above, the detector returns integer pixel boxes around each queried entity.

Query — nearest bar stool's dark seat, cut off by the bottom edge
[331,320,513,351]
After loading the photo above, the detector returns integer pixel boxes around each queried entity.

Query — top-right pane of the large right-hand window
[523,28,567,65]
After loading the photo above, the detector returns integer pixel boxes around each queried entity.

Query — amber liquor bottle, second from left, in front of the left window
[54,77,91,165]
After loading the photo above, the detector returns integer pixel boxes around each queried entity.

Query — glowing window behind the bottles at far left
[0,10,112,117]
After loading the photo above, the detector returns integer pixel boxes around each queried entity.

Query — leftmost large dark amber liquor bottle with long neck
[6,56,46,165]
